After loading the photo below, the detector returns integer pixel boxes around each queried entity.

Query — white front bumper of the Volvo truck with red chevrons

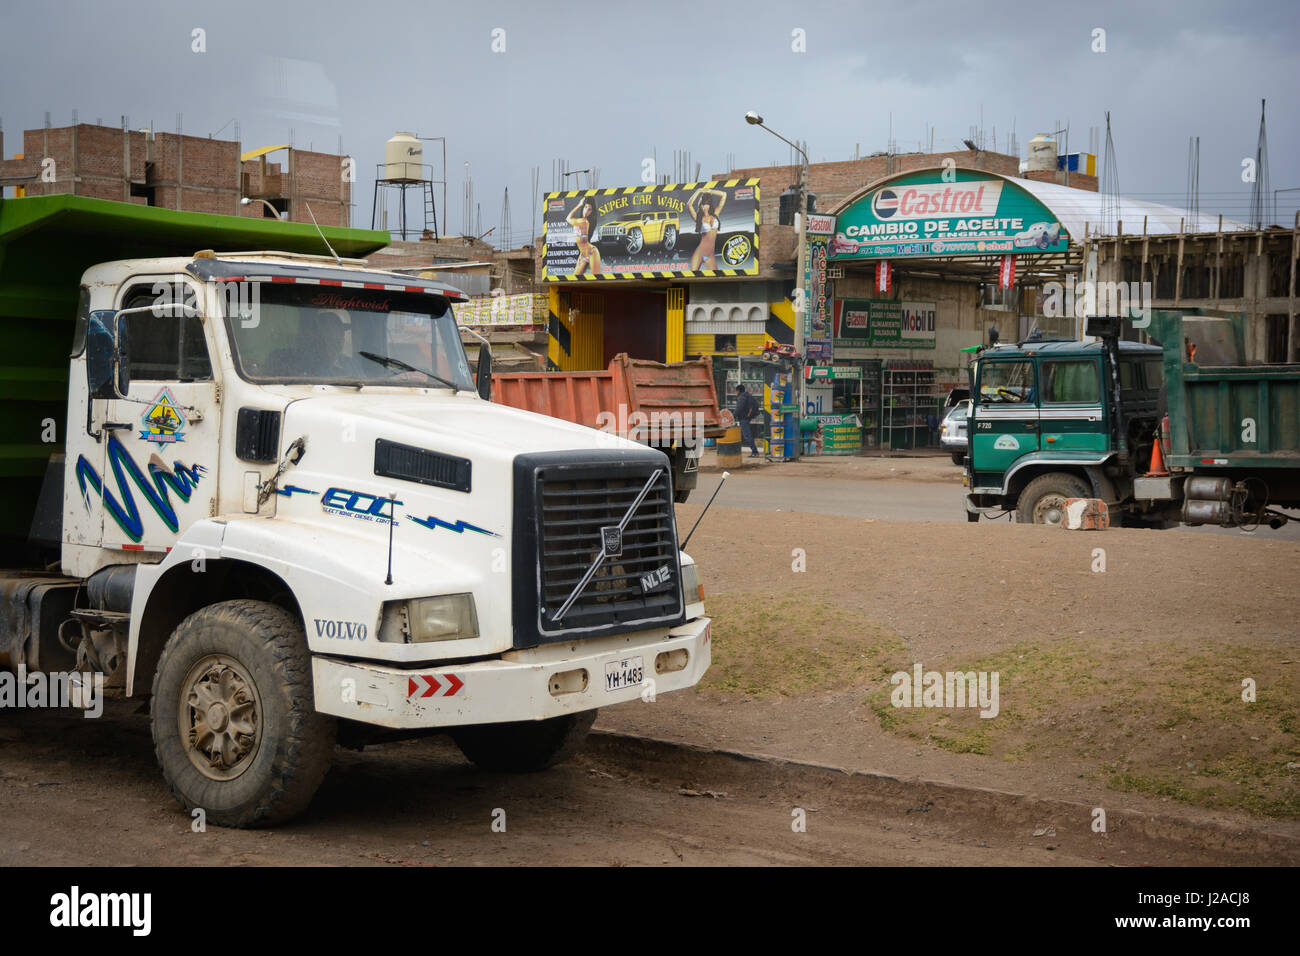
[312,618,711,730]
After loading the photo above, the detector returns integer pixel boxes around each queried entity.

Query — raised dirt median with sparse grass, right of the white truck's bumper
[597,503,1300,848]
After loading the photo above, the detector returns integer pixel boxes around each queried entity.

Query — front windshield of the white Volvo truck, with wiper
[226,282,473,390]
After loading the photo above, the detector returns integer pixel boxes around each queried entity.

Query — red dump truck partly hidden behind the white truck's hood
[491,352,720,501]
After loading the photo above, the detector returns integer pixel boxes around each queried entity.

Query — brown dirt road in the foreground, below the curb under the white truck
[0,701,1300,868]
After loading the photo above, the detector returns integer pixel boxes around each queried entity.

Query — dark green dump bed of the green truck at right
[1148,312,1300,471]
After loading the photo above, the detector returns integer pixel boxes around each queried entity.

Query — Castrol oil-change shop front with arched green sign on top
[803,166,1078,454]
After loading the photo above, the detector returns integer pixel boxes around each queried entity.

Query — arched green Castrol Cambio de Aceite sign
[831,169,1070,261]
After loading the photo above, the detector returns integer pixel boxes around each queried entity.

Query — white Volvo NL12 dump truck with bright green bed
[0,196,710,826]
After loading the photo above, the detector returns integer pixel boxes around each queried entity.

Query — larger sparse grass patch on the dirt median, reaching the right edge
[867,637,1300,818]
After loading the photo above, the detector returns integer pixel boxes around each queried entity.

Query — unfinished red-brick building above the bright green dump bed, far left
[0,124,352,225]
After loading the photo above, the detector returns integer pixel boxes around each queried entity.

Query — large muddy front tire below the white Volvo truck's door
[151,601,337,827]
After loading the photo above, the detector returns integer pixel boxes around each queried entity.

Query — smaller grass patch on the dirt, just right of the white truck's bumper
[699,594,907,698]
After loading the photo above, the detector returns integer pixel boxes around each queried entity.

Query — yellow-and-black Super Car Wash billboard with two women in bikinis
[542,178,758,282]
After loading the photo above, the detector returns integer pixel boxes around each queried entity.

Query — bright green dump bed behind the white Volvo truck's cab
[0,195,389,535]
